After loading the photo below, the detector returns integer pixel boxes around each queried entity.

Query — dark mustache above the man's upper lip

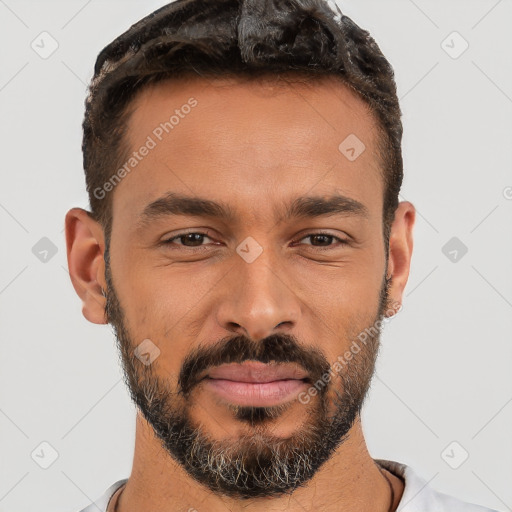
[178,334,330,396]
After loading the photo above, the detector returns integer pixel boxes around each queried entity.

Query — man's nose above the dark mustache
[217,247,301,340]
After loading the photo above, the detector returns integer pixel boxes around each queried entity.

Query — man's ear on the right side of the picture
[387,201,416,309]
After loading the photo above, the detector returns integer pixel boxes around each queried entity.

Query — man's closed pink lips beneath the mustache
[202,361,310,407]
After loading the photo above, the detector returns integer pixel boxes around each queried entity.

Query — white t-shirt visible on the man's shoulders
[81,459,496,512]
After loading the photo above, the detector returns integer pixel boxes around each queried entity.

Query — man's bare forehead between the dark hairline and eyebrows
[113,73,383,225]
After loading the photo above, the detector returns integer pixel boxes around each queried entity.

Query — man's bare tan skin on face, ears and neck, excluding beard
[66,74,415,512]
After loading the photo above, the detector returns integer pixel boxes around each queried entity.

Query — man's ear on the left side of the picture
[66,208,107,324]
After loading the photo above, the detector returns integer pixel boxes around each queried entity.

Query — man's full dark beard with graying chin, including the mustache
[105,249,391,499]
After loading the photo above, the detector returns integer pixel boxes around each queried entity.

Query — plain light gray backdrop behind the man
[0,0,512,512]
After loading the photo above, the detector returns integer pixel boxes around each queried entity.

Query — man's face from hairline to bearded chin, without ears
[69,74,412,497]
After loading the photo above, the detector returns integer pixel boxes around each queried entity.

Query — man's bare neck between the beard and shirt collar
[115,414,403,512]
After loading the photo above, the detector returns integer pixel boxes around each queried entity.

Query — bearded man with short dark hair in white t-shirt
[66,0,496,512]
